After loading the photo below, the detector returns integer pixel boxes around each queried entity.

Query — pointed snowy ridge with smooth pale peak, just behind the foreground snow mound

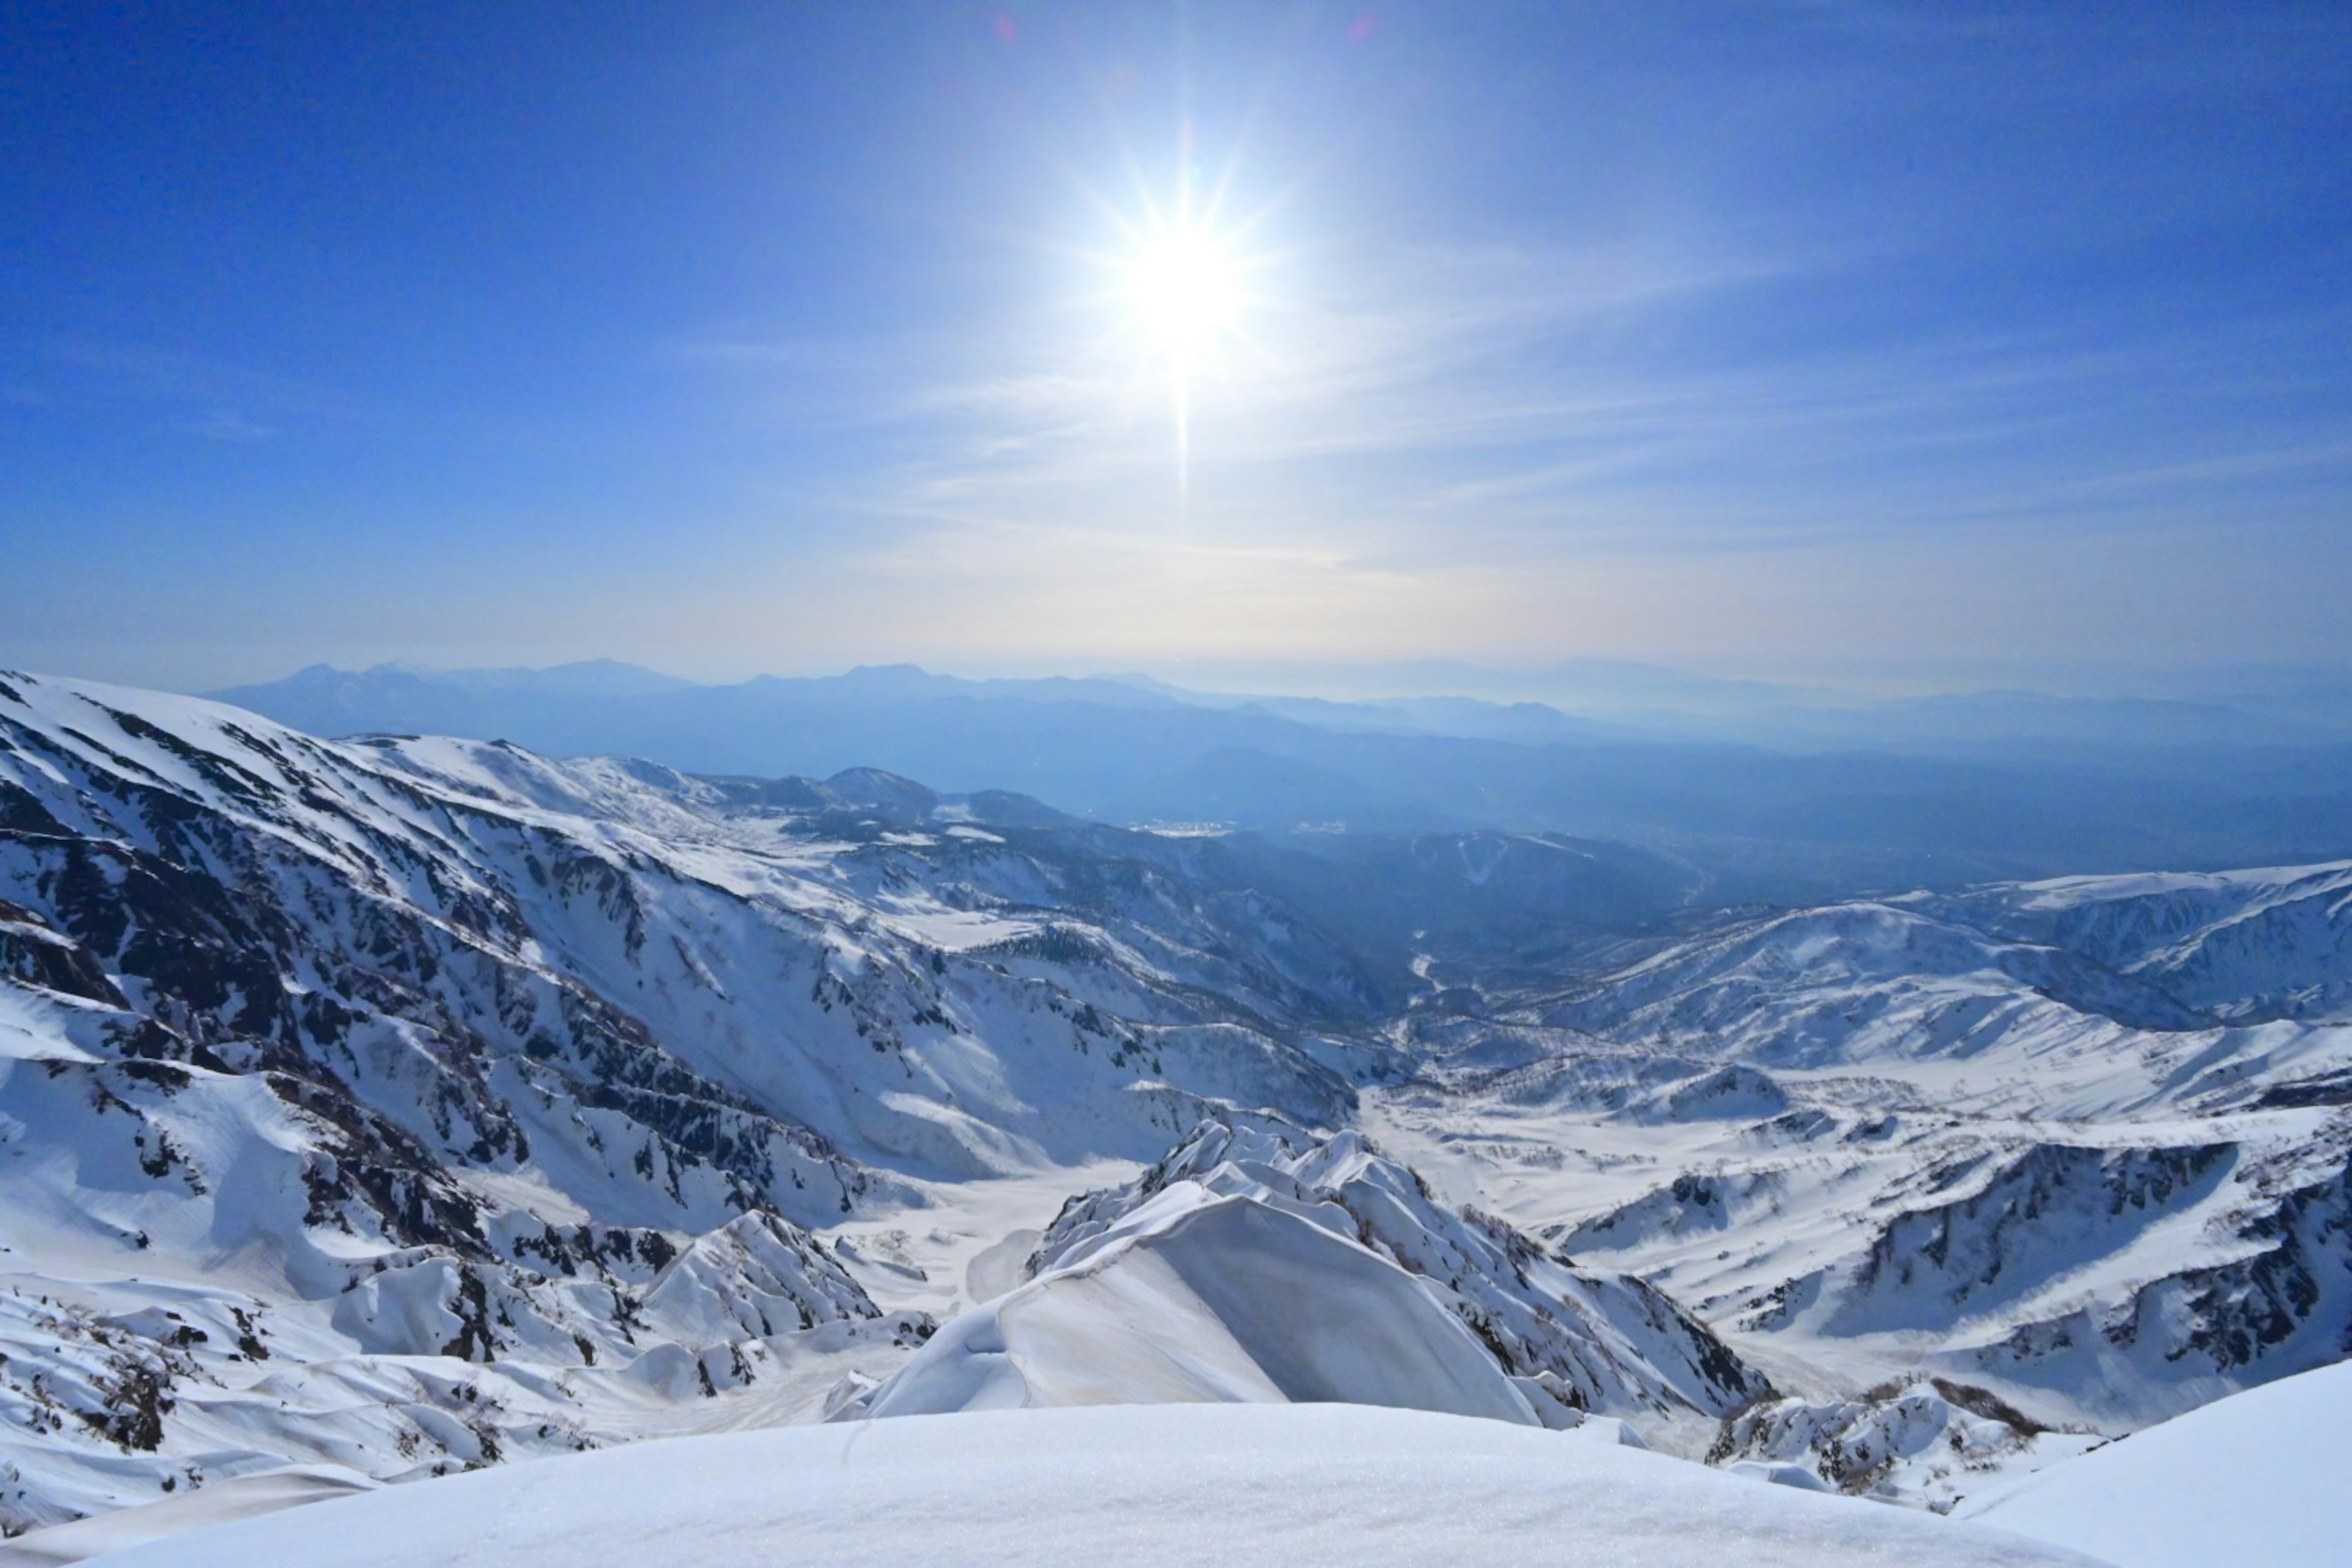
[842,1121,1771,1450]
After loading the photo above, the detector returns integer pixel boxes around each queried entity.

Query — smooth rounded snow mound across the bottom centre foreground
[96,1406,2095,1568]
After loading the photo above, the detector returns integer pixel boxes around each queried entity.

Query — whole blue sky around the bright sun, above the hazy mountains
[0,2,2352,687]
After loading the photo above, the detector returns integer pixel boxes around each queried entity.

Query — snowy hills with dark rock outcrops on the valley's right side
[1366,867,2352,1504]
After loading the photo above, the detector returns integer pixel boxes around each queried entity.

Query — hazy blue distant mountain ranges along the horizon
[214,663,2352,903]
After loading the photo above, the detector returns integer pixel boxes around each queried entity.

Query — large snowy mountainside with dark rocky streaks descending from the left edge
[0,675,1357,1531]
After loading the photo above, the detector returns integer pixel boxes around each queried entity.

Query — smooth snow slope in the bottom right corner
[1959,1363,2352,1568]
